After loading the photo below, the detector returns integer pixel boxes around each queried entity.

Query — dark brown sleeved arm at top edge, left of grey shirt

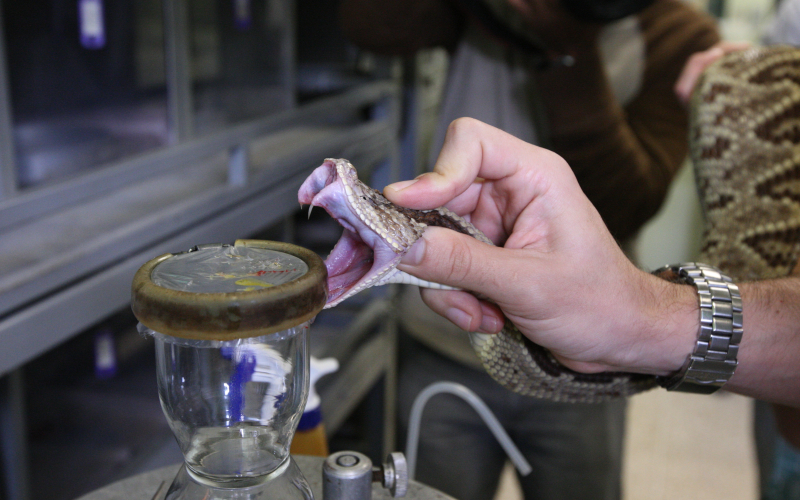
[339,0,462,56]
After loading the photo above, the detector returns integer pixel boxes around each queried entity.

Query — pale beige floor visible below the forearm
[495,390,758,500]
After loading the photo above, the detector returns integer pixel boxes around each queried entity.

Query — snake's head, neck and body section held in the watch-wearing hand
[298,159,656,403]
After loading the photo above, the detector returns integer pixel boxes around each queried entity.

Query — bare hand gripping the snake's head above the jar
[384,118,699,374]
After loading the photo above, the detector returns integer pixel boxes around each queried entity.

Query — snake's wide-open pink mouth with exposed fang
[297,159,402,308]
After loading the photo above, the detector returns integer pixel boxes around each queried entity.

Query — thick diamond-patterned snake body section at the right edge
[689,46,800,281]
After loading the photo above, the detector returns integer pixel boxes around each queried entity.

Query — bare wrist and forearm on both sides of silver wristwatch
[640,278,800,407]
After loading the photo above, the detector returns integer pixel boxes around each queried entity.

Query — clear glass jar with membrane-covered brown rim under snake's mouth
[132,240,327,500]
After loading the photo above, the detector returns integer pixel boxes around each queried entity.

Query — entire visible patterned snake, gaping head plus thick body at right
[298,47,800,402]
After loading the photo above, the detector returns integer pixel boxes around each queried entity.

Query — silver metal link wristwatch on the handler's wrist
[653,262,742,394]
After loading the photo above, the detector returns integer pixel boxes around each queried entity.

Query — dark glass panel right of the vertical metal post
[188,0,294,135]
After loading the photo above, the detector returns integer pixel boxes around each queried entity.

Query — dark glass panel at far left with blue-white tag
[2,0,167,187]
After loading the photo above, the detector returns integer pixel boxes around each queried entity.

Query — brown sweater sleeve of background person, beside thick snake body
[539,0,719,240]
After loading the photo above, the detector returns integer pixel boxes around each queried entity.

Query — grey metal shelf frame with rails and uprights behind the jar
[0,0,401,500]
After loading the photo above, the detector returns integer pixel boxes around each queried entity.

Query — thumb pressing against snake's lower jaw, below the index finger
[397,227,519,298]
